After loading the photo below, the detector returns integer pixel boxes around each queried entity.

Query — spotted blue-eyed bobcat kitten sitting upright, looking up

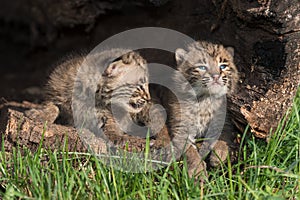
[156,41,238,173]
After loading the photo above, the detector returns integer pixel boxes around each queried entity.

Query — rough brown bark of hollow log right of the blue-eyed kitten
[231,0,300,138]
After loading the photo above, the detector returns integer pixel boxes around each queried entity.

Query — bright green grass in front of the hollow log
[0,91,300,199]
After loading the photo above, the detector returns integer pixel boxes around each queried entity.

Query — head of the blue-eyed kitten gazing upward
[175,41,238,96]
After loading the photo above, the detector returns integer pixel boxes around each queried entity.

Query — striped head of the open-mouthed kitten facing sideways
[102,52,150,113]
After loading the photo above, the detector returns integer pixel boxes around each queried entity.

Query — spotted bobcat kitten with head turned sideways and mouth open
[47,49,150,138]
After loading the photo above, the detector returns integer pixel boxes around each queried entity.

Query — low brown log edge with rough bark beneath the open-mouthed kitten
[0,101,170,154]
